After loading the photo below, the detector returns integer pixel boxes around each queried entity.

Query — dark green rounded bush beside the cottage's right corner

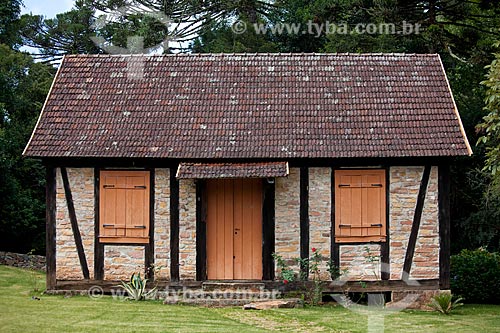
[450,249,500,303]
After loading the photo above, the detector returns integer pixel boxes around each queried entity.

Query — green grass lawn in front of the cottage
[0,266,500,333]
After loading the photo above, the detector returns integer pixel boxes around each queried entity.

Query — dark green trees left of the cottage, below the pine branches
[0,45,55,253]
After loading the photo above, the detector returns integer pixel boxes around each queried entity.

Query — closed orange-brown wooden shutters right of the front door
[335,170,386,243]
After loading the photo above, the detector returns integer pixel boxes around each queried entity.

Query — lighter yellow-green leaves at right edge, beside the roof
[478,47,500,176]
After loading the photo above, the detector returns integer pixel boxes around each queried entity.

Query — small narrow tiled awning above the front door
[176,162,289,179]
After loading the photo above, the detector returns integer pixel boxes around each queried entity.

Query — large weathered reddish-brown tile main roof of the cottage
[25,54,470,159]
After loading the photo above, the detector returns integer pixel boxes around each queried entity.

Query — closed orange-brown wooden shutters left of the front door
[99,171,150,243]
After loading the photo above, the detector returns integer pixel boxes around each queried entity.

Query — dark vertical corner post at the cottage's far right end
[438,165,451,289]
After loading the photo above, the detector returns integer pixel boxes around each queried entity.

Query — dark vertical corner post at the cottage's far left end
[45,167,57,290]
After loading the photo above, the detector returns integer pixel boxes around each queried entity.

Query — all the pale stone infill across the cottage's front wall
[56,166,439,280]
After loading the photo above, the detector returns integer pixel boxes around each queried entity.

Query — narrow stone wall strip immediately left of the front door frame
[179,179,196,280]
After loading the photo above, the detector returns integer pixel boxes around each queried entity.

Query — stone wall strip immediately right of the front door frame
[275,168,300,276]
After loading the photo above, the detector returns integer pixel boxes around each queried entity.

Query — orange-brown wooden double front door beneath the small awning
[207,179,262,280]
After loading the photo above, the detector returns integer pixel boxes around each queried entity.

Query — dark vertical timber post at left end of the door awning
[170,168,179,281]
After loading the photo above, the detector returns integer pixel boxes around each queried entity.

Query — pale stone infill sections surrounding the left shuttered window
[56,168,170,280]
